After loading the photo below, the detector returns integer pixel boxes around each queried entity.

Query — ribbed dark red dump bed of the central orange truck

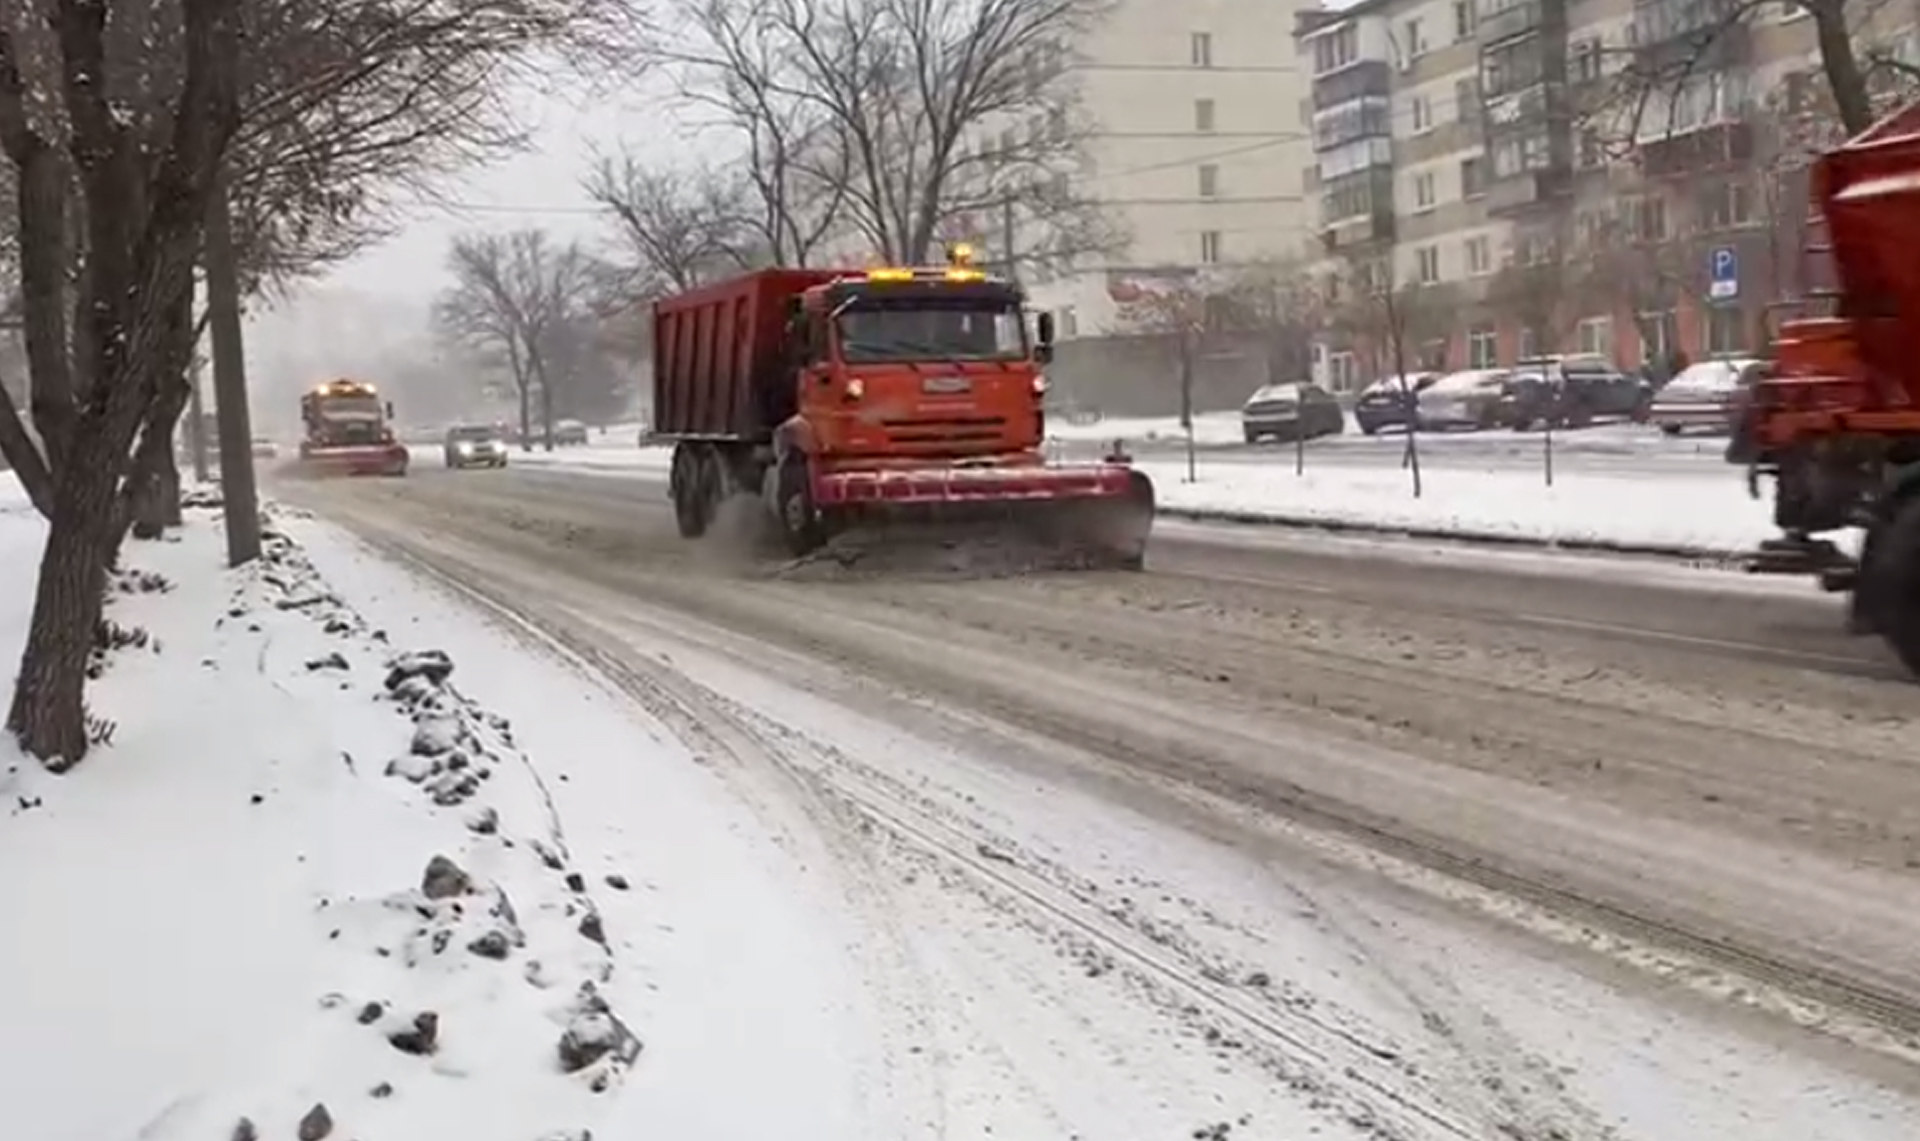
[653,269,837,442]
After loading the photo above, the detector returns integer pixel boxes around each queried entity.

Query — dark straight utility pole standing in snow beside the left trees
[205,173,259,567]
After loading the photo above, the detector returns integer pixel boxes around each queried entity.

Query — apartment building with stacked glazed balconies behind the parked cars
[1294,0,1914,382]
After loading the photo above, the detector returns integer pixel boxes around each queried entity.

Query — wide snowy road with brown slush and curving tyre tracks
[276,471,1920,1141]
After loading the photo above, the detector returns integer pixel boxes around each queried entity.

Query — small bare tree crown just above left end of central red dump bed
[586,154,760,288]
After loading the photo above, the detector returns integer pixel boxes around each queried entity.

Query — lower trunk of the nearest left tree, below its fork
[8,423,119,772]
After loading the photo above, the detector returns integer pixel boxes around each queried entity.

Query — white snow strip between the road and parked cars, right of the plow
[1139,457,1776,551]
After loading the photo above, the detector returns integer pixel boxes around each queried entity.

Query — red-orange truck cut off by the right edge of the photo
[1728,104,1920,676]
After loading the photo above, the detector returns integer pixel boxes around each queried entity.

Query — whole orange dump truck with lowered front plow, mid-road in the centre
[653,246,1154,569]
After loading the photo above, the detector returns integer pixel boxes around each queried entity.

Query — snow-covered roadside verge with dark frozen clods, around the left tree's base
[0,480,845,1141]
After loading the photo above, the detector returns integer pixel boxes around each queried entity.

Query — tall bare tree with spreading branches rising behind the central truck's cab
[672,0,1112,261]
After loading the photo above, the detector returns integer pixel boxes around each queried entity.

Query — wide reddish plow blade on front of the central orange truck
[814,465,1154,571]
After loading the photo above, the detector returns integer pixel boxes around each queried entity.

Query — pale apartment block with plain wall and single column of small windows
[1021,0,1313,336]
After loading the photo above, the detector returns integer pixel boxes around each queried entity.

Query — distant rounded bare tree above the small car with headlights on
[434,231,603,451]
